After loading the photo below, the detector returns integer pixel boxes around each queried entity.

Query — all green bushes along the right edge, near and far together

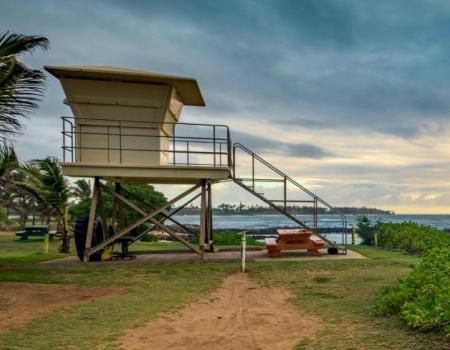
[361,220,450,342]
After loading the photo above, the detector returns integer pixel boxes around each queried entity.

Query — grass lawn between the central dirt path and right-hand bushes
[250,246,449,350]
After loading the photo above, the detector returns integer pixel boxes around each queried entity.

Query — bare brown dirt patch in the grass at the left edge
[0,282,118,332]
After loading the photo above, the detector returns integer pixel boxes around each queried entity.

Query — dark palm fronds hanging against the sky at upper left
[0,32,48,141]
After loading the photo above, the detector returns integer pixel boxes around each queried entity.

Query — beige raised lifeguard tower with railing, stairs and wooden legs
[45,66,346,262]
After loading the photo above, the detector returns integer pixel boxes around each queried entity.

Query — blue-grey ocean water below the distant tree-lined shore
[172,214,450,244]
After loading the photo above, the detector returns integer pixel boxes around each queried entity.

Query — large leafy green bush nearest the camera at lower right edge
[374,246,450,339]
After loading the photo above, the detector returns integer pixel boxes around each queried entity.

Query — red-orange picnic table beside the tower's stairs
[266,229,325,257]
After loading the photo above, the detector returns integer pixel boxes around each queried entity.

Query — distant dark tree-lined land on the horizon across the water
[178,203,395,215]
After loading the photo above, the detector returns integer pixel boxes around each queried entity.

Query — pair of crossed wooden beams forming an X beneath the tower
[85,184,201,255]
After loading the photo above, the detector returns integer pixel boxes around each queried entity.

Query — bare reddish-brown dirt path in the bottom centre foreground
[121,274,321,350]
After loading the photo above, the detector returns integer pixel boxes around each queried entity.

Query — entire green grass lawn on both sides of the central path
[0,236,448,349]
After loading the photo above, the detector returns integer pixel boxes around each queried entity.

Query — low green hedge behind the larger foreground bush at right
[376,222,450,254]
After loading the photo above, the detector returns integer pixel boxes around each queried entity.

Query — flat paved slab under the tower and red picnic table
[40,249,366,265]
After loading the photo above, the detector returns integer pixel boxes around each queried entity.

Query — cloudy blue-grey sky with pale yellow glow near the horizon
[0,0,450,214]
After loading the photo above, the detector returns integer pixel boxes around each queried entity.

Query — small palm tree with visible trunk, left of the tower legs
[18,157,71,253]
